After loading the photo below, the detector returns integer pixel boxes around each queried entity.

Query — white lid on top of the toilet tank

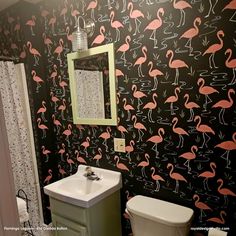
[126,195,193,226]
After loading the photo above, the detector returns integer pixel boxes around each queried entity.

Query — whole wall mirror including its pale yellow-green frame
[67,43,117,125]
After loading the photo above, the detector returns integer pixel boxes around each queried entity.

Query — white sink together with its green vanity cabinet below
[44,165,122,236]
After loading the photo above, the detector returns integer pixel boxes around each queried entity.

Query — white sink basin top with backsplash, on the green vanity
[44,165,122,208]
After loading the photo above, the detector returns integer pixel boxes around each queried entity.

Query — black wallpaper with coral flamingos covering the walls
[0,0,236,235]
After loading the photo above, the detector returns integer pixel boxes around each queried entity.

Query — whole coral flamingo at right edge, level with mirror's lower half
[212,88,235,125]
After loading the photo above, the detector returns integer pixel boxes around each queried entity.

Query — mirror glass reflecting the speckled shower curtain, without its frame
[74,52,111,119]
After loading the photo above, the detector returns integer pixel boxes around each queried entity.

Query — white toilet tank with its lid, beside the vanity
[126,195,193,236]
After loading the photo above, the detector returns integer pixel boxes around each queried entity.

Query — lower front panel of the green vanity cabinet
[52,214,88,236]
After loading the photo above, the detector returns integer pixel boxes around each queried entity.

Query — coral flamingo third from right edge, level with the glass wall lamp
[180,17,201,56]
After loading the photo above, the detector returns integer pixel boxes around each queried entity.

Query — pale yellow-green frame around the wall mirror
[67,43,117,125]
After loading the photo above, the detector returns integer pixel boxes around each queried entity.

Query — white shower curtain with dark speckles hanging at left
[0,61,42,236]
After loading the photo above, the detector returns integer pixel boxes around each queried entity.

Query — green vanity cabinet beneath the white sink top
[50,191,121,236]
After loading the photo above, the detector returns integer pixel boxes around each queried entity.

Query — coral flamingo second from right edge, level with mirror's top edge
[202,30,225,69]
